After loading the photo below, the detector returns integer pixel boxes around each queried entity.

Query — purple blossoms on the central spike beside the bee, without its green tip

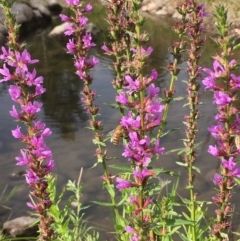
[116,47,164,240]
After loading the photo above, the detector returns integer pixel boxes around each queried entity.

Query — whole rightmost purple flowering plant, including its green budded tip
[203,5,240,240]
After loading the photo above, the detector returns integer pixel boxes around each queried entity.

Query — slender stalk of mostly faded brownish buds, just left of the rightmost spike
[173,0,208,241]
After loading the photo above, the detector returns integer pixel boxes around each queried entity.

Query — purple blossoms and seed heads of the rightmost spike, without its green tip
[203,56,240,236]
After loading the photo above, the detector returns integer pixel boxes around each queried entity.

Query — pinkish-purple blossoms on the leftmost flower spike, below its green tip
[0,47,54,240]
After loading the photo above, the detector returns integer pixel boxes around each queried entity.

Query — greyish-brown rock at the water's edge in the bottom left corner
[3,216,38,237]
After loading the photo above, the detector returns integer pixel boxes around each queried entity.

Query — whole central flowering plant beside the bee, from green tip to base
[103,0,167,240]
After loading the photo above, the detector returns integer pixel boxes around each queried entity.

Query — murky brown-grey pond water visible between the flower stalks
[0,0,240,240]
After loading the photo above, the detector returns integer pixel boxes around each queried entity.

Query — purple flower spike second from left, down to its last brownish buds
[60,0,101,121]
